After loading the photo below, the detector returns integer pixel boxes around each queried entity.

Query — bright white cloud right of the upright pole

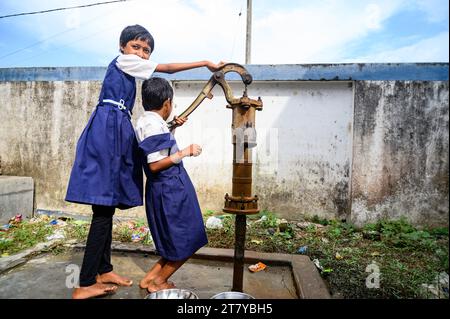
[252,0,403,64]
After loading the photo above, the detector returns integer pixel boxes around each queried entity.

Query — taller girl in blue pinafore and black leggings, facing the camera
[66,25,222,299]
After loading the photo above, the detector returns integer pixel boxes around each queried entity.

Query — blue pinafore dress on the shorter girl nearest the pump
[139,133,208,261]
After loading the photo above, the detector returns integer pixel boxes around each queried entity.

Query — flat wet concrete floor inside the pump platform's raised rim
[0,250,298,299]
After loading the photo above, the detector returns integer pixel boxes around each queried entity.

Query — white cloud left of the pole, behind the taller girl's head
[0,0,245,62]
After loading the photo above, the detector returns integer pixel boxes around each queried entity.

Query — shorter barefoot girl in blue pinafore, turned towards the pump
[136,78,208,292]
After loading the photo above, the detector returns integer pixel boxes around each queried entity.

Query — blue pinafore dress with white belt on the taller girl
[65,58,143,209]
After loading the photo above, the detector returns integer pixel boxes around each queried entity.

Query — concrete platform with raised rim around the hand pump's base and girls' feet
[0,244,330,299]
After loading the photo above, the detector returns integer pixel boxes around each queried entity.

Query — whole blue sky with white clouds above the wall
[0,0,449,68]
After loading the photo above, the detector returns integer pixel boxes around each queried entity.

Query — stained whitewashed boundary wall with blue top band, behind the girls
[0,63,448,225]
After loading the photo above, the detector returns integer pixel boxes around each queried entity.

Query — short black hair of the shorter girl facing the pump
[142,77,173,111]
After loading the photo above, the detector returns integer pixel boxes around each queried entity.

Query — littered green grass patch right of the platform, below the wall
[207,212,448,298]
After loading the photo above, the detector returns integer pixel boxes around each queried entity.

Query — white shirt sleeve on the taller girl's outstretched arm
[116,54,158,80]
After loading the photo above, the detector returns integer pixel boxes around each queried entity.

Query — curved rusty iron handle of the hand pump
[167,63,262,129]
